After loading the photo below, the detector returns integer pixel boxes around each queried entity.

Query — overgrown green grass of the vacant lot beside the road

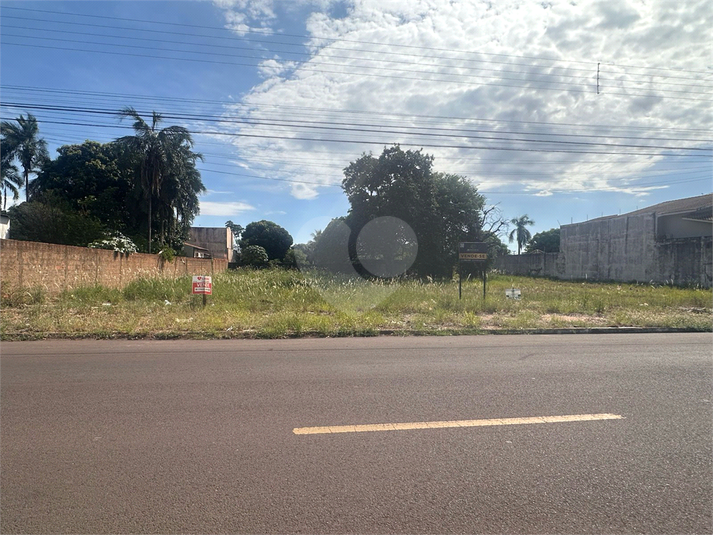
[0,270,713,340]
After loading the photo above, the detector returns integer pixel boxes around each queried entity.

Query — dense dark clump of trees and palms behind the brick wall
[0,107,205,253]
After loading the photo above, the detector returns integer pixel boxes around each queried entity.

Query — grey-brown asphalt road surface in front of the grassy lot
[0,334,713,533]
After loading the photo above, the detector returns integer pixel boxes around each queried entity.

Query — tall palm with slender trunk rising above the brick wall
[116,107,197,253]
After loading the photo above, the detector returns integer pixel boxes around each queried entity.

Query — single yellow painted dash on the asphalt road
[292,414,623,435]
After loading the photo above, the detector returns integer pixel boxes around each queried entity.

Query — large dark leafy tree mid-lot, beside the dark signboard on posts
[342,145,499,278]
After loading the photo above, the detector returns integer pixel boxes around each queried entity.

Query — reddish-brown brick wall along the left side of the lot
[0,240,228,294]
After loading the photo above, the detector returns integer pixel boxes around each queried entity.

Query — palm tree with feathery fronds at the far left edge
[0,113,49,201]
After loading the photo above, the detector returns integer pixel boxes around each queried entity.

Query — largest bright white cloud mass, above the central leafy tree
[213,0,713,199]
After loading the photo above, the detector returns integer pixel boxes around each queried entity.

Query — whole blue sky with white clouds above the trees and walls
[0,0,713,250]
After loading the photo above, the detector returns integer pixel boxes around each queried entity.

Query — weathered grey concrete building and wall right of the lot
[496,194,713,288]
